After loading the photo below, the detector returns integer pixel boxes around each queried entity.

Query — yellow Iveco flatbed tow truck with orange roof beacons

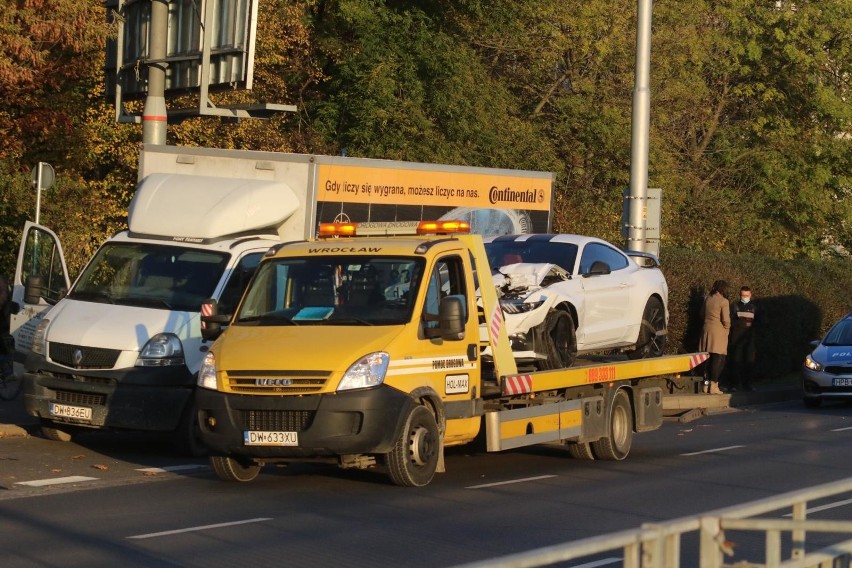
[196,221,706,486]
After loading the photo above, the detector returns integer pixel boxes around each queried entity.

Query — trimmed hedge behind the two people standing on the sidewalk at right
[660,249,852,379]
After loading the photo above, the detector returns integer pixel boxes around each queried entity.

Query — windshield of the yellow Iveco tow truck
[234,256,424,325]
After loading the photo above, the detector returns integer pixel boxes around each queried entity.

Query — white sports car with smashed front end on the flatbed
[485,234,668,369]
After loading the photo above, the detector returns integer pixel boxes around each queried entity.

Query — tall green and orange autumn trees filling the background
[0,0,852,278]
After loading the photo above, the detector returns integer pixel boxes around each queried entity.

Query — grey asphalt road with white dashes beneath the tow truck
[0,402,852,567]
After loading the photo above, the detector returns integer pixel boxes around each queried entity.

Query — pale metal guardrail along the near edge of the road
[457,478,852,568]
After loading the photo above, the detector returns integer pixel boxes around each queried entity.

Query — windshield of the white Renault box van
[68,242,229,312]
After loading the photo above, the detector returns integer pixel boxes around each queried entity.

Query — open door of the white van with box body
[11,221,70,360]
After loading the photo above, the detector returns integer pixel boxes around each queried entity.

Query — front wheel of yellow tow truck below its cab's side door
[387,406,440,487]
